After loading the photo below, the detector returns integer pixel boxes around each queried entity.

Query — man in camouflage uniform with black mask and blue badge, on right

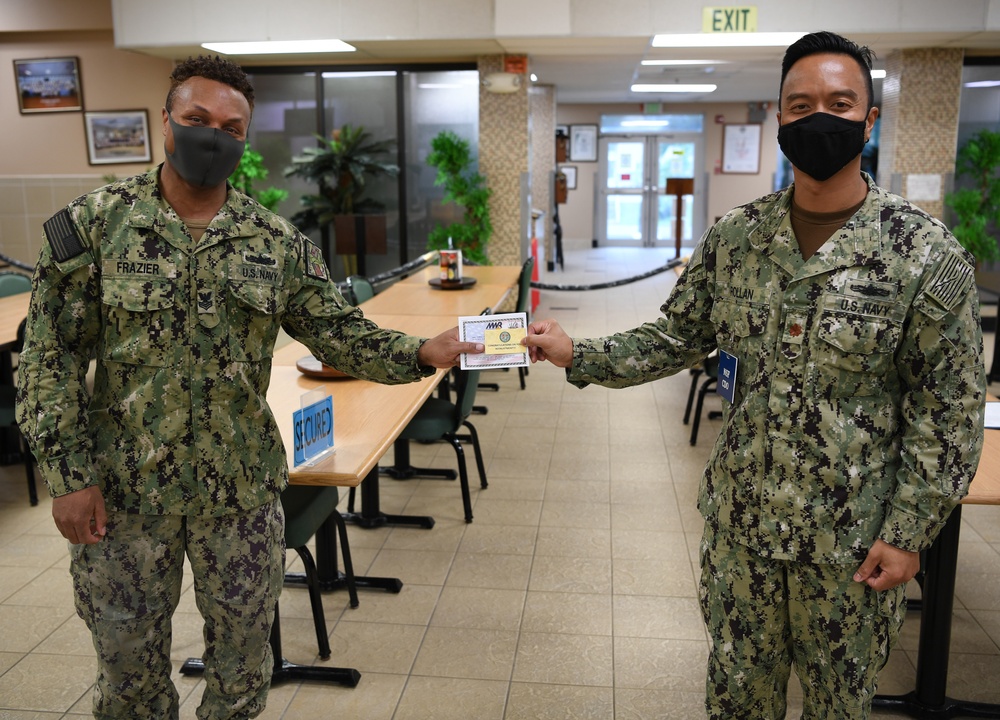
[526,33,985,720]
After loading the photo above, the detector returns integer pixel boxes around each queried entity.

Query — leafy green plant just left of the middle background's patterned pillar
[427,130,493,265]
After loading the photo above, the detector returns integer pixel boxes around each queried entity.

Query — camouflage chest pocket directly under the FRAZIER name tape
[101,276,178,367]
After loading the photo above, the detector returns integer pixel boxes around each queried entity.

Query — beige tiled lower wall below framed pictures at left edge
[0,175,104,265]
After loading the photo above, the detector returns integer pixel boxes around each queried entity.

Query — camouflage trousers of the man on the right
[700,523,905,720]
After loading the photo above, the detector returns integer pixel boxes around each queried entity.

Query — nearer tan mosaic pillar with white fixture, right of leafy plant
[477,55,529,265]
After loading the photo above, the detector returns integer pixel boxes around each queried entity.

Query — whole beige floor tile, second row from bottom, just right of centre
[513,632,614,687]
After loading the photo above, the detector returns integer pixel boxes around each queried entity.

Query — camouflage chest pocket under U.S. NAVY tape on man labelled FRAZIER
[227,280,287,362]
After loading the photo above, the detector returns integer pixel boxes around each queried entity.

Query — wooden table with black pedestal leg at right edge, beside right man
[872,430,1000,718]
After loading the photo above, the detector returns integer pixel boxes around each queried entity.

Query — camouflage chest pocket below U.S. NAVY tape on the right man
[813,310,901,397]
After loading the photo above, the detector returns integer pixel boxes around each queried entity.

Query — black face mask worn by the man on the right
[778,113,866,182]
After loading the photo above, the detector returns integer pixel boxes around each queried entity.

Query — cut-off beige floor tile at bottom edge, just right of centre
[504,682,615,720]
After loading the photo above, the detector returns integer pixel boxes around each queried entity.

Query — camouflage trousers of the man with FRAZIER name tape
[70,500,285,720]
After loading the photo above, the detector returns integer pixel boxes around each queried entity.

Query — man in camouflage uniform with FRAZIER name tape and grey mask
[18,58,481,719]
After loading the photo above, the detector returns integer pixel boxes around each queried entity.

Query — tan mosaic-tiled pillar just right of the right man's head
[878,48,963,218]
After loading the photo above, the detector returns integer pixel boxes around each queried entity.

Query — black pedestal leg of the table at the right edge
[872,505,1000,720]
